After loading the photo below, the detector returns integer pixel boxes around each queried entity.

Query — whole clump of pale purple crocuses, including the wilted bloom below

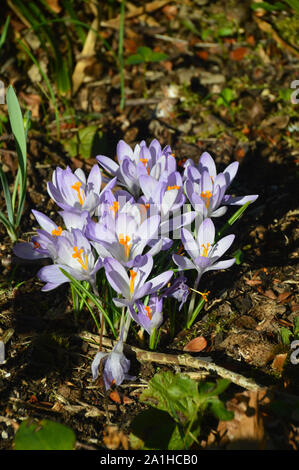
[13,139,258,389]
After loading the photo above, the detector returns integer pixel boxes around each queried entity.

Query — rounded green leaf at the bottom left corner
[15,419,76,450]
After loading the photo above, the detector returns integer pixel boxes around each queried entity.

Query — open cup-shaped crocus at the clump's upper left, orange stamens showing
[48,165,116,215]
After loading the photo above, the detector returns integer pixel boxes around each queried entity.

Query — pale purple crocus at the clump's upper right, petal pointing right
[184,152,258,219]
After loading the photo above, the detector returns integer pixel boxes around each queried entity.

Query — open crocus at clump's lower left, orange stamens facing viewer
[37,229,103,294]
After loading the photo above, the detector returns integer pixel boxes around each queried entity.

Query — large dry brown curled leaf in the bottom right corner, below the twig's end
[217,390,265,450]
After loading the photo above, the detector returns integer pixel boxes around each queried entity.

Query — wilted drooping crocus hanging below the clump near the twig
[91,339,135,390]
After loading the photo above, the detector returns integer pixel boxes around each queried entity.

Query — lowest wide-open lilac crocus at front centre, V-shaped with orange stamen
[104,255,173,307]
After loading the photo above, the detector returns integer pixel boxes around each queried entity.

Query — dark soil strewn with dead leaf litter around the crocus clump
[0,0,299,450]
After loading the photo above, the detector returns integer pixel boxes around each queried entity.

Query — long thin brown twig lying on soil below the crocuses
[79,331,266,390]
